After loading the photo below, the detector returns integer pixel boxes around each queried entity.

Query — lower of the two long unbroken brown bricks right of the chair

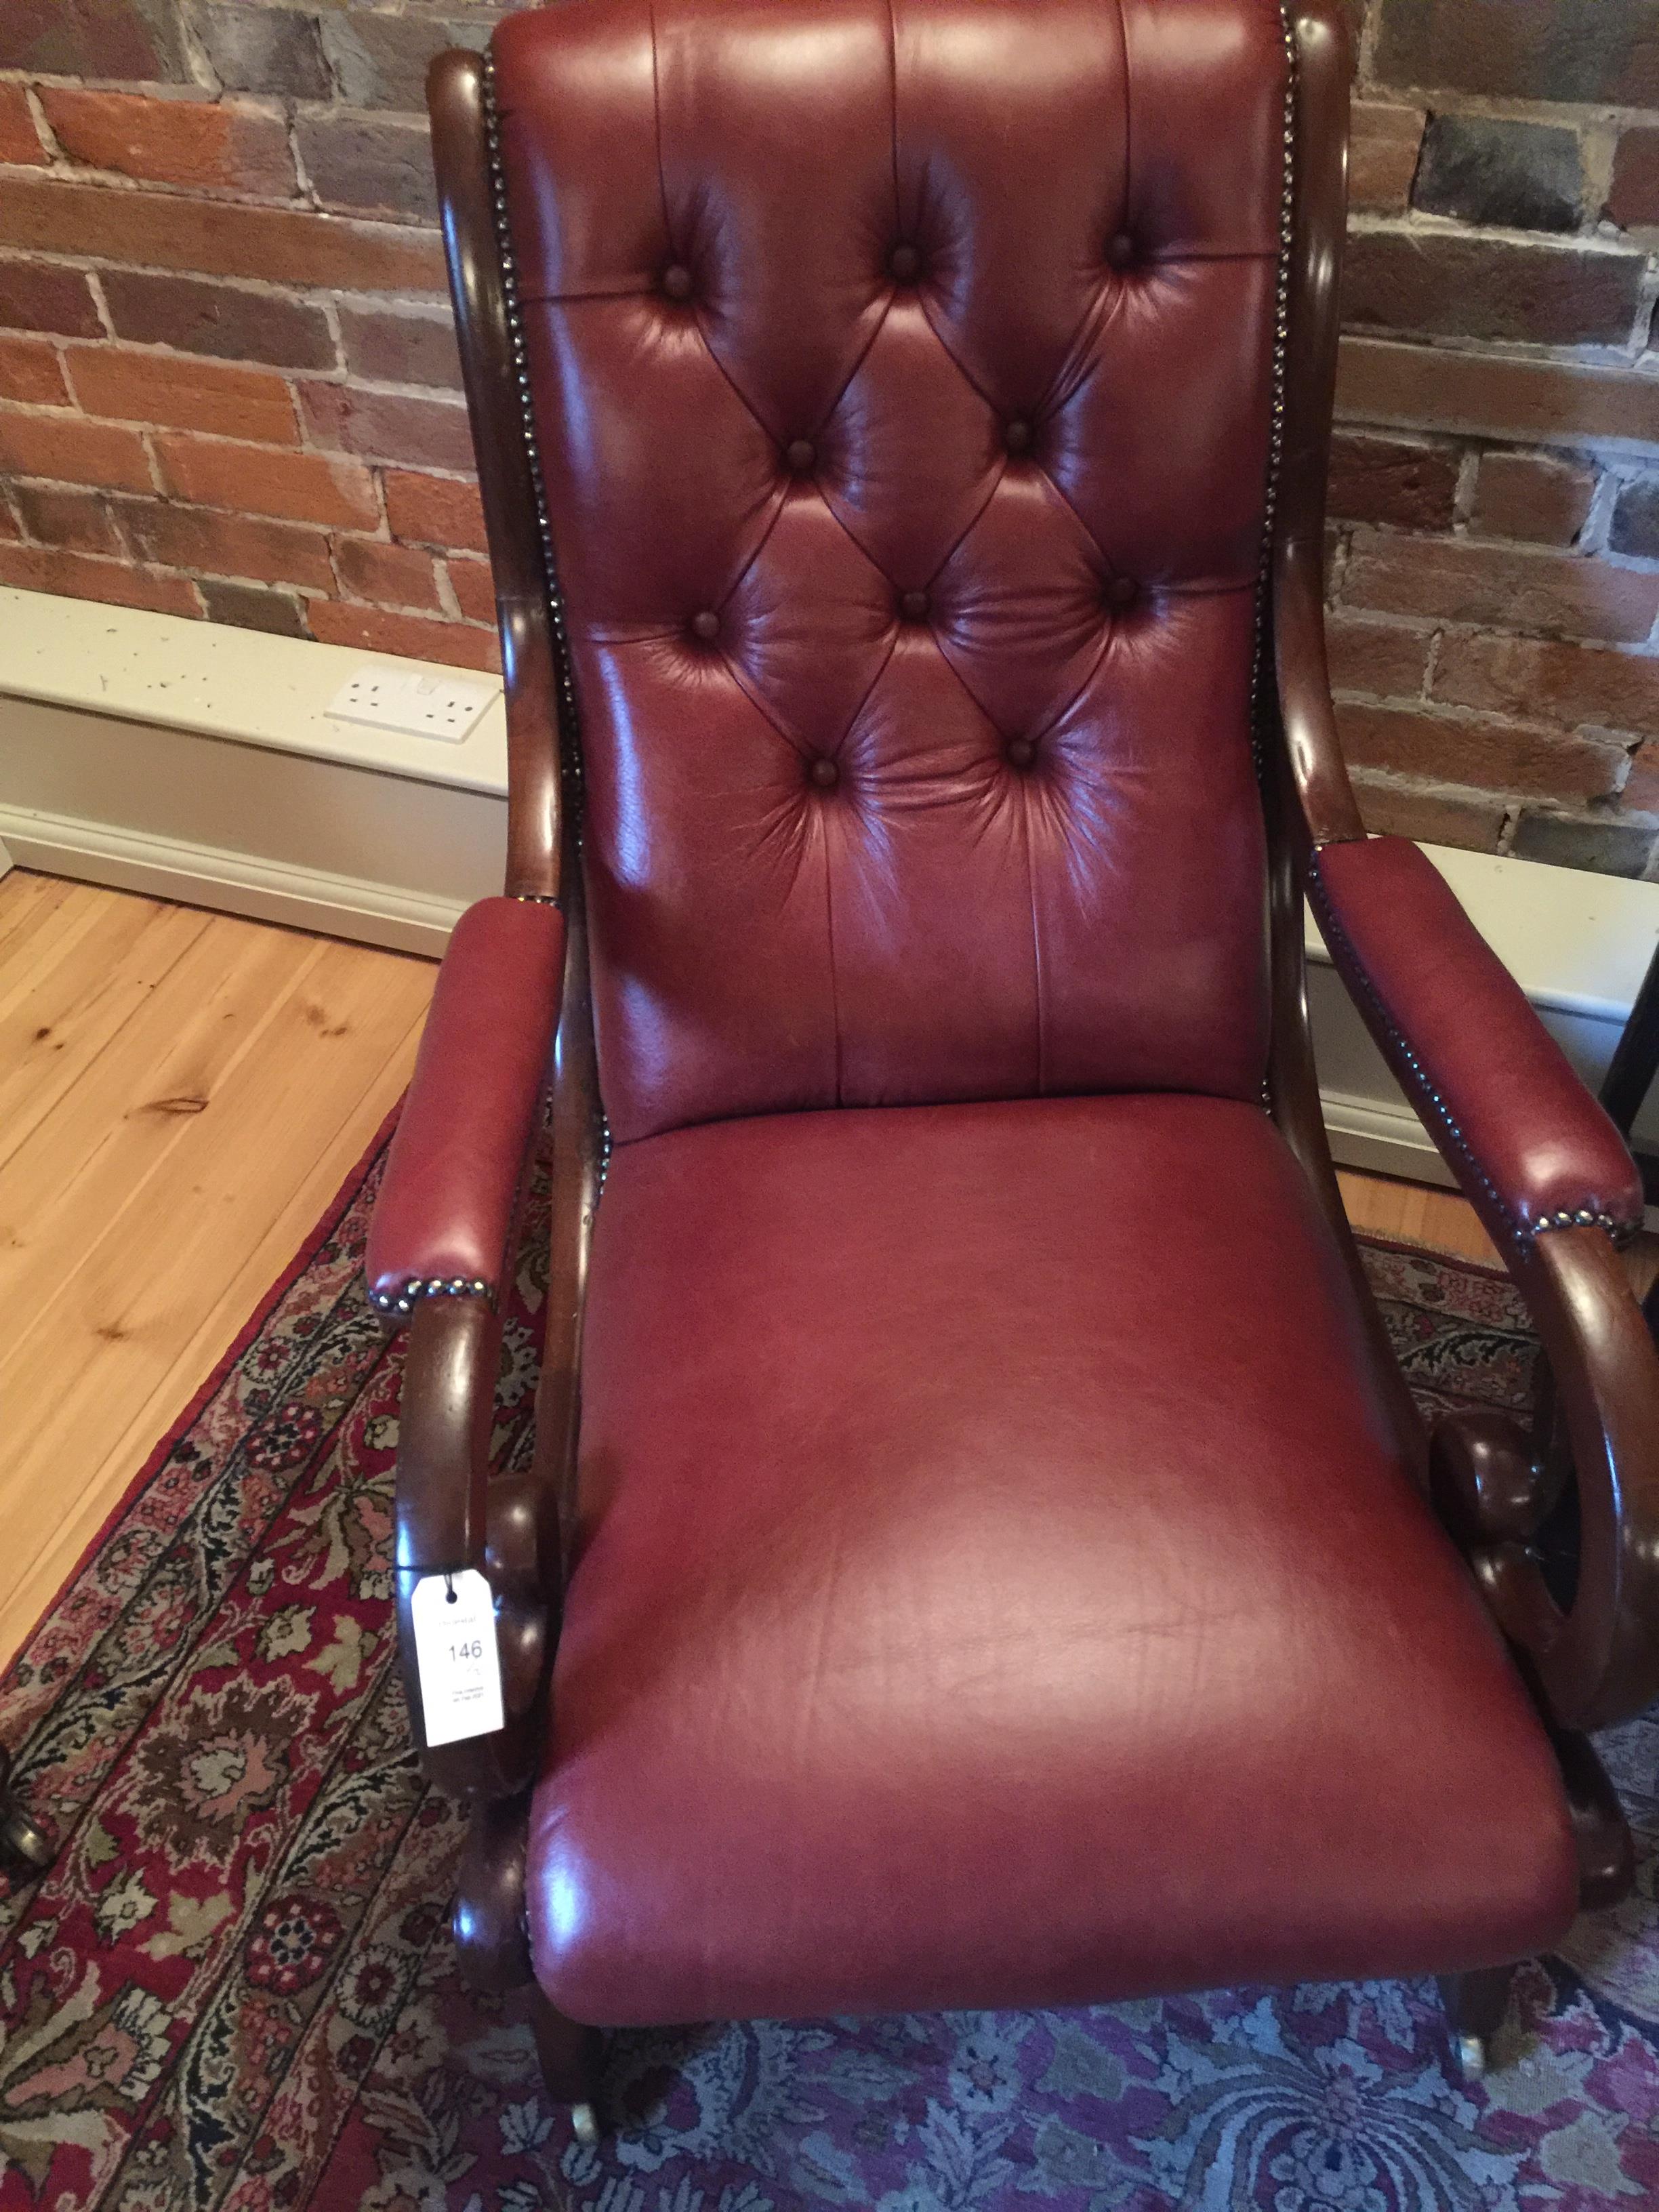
[1343,531,1659,644]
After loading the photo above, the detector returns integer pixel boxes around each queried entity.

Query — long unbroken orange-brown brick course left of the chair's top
[0,177,445,292]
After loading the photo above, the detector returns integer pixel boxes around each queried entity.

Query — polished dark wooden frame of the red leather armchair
[382,0,1659,2123]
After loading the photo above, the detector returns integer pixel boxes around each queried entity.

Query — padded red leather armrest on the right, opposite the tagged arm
[1307,838,1641,1248]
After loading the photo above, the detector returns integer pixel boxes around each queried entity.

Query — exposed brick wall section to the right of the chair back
[1330,0,1659,876]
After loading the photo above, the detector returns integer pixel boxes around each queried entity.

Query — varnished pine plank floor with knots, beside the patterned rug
[0,869,1659,1666]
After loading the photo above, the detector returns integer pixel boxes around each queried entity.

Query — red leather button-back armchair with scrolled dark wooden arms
[369,0,1659,2117]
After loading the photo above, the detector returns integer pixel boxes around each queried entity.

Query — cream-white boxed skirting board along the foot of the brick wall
[0,590,1659,1225]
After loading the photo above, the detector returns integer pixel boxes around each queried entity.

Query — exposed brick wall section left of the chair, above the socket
[0,0,502,665]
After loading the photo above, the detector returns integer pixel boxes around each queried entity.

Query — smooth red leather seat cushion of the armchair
[529,1097,1575,2024]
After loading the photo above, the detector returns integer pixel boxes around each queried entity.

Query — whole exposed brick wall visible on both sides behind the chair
[0,0,1659,876]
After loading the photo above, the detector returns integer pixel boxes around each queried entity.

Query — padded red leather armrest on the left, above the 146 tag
[367,898,564,1314]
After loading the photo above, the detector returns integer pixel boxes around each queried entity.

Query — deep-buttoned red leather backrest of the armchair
[495,0,1285,1139]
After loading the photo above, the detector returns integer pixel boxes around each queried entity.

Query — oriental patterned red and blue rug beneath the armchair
[0,1157,1659,2212]
